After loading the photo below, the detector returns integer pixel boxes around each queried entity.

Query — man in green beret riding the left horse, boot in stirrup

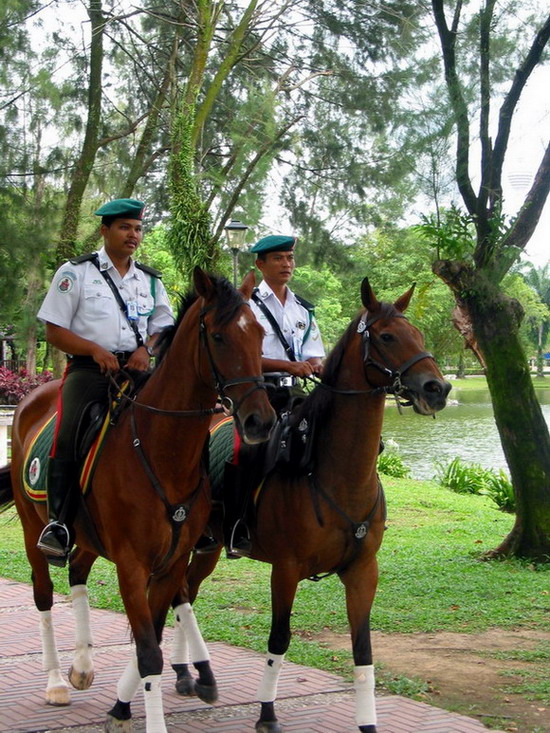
[38,199,174,567]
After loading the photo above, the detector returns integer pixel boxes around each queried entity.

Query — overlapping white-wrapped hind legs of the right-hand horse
[170,547,222,704]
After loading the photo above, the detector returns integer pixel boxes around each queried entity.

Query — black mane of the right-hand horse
[295,303,398,423]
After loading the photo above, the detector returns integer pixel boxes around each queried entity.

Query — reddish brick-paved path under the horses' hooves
[0,578,498,733]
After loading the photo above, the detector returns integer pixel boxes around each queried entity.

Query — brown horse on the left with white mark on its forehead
[0,268,275,733]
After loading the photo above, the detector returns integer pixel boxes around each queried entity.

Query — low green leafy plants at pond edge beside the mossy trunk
[437,457,515,513]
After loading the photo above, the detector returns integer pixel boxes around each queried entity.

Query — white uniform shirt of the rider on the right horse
[250,280,325,361]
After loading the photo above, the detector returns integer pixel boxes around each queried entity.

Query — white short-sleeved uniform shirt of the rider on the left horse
[37,247,174,351]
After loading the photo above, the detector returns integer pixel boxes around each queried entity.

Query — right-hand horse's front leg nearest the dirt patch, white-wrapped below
[341,557,378,733]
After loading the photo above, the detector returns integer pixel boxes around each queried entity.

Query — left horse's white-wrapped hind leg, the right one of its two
[68,548,97,690]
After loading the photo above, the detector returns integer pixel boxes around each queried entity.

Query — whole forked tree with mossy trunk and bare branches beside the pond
[424,0,550,560]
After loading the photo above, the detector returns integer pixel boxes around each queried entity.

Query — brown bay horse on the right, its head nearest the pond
[172,278,451,733]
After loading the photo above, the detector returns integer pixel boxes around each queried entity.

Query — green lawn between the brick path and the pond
[0,477,550,702]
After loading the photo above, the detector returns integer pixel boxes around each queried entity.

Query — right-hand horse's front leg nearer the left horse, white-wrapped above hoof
[255,566,298,733]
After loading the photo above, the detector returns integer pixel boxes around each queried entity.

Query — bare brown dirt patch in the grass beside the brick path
[314,629,550,733]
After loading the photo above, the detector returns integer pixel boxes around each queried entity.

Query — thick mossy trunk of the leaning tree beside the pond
[433,260,550,561]
